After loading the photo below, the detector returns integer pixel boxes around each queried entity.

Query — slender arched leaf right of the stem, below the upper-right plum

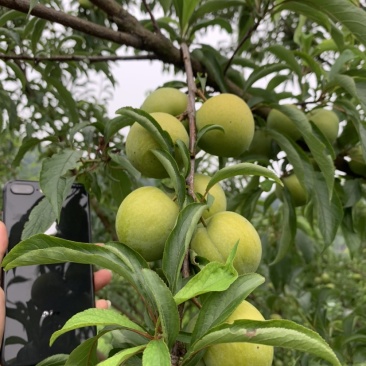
[205,163,282,194]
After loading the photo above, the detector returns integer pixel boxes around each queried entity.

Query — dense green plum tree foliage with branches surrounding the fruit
[0,0,366,366]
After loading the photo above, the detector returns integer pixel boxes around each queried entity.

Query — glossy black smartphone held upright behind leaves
[1,180,95,366]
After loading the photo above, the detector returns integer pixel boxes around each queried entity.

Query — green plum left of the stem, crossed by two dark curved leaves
[126,112,189,179]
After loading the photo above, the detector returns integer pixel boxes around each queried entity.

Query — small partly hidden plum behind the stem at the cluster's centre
[193,173,226,219]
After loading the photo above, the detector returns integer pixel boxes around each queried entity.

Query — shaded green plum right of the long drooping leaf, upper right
[307,108,339,143]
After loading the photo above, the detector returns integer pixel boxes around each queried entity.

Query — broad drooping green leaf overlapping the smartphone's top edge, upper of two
[39,149,82,219]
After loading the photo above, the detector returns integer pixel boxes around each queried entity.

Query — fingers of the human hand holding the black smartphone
[0,221,112,342]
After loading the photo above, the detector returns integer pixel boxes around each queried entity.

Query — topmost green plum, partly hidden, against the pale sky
[141,88,188,116]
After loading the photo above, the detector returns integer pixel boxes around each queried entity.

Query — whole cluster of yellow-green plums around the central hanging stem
[116,87,273,366]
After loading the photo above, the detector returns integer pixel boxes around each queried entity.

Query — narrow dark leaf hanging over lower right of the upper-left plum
[151,149,186,208]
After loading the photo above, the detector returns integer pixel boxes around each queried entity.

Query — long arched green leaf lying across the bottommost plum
[186,320,341,366]
